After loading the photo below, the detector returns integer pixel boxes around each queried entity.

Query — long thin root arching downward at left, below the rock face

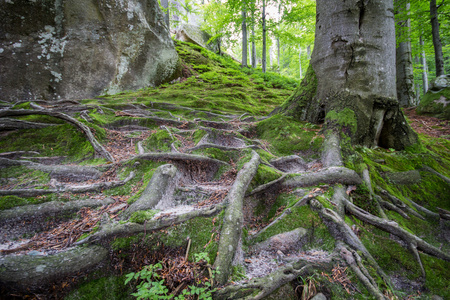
[0,109,114,162]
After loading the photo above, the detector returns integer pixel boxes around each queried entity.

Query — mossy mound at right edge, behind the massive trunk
[416,87,450,120]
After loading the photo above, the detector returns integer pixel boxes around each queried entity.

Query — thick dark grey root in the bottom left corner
[0,246,108,291]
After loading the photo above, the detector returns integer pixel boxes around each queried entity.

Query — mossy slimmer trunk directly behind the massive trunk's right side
[395,0,414,107]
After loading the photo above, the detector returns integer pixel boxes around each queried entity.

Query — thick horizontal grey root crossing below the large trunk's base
[283,167,362,188]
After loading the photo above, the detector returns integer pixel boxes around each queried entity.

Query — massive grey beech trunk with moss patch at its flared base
[274,0,417,149]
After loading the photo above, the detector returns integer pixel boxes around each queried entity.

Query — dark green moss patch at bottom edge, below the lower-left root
[64,275,134,300]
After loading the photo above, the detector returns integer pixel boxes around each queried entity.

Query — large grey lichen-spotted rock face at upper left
[0,0,178,101]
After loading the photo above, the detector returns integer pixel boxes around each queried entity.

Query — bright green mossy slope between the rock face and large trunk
[91,41,297,116]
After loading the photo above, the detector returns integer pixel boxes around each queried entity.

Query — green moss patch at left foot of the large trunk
[256,115,323,159]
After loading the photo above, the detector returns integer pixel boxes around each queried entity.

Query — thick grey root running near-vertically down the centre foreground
[214,151,260,284]
